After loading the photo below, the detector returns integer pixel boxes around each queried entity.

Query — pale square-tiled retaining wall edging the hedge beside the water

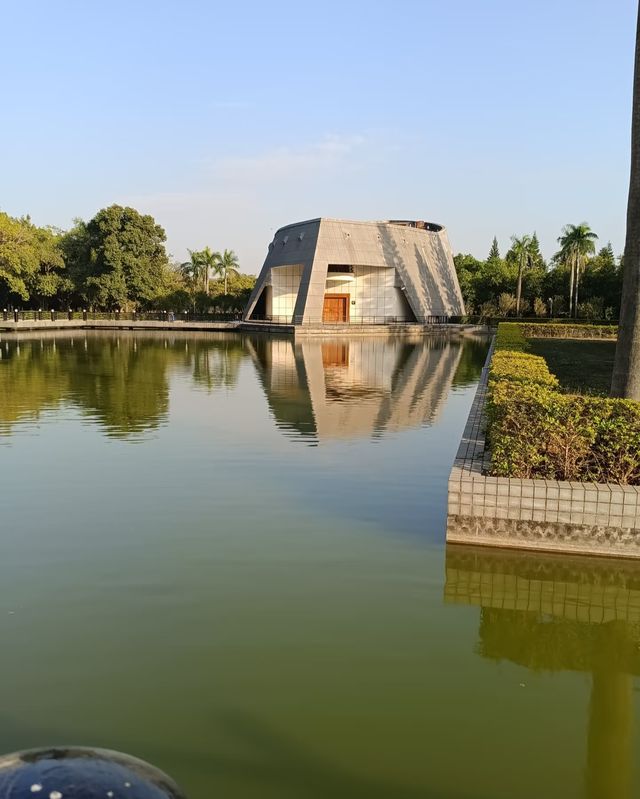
[447,345,640,557]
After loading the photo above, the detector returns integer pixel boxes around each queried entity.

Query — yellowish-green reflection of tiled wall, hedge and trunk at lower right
[444,546,640,799]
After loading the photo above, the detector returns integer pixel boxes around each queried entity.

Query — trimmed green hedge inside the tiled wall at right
[486,324,640,485]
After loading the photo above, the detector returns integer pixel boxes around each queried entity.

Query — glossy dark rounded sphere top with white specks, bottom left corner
[0,747,186,799]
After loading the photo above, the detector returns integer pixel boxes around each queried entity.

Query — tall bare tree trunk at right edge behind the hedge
[611,1,640,400]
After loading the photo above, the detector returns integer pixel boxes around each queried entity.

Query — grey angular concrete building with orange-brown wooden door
[244,218,464,325]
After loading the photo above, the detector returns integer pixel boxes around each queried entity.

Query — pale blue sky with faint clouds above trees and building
[0,0,637,273]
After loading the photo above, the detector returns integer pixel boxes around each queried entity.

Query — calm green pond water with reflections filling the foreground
[0,333,640,799]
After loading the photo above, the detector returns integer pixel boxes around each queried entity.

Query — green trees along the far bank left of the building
[0,205,255,311]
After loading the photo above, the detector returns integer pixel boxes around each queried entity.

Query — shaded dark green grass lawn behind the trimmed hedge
[529,338,616,396]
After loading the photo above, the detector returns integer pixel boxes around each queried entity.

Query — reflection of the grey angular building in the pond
[250,338,461,441]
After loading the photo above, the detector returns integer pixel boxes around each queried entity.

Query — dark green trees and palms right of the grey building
[453,222,623,320]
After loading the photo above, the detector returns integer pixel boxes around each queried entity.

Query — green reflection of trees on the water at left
[0,333,252,438]
